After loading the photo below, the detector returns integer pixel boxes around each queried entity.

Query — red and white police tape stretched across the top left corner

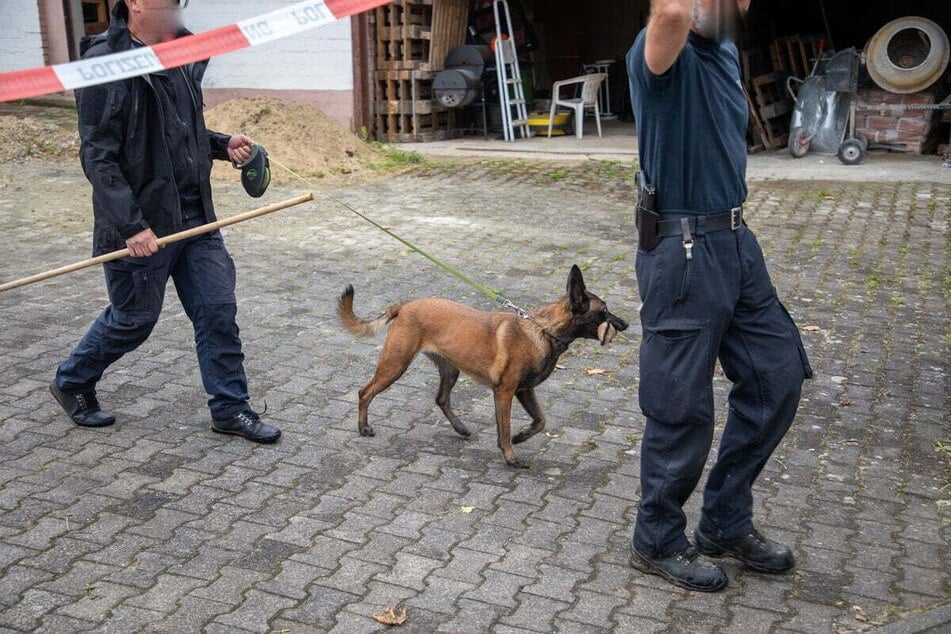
[0,0,390,102]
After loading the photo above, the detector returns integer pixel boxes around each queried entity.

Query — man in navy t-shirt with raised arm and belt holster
[627,0,812,591]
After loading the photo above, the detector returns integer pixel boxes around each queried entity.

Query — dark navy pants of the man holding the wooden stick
[56,221,249,419]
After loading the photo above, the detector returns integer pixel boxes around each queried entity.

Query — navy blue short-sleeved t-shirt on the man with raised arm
[627,29,749,213]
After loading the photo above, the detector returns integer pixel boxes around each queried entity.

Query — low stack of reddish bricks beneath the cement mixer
[855,90,937,154]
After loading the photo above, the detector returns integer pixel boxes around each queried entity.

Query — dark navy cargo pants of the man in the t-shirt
[633,218,812,557]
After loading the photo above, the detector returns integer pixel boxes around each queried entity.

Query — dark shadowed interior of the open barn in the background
[432,0,951,148]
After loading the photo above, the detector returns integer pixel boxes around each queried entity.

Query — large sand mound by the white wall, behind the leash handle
[205,97,383,182]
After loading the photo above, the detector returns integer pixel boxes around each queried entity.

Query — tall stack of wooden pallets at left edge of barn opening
[373,0,469,143]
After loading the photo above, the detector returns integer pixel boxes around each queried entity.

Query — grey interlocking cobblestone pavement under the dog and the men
[0,161,951,633]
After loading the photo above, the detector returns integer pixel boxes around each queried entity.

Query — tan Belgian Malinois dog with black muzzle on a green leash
[337,266,628,469]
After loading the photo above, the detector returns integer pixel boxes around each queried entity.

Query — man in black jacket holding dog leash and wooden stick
[50,0,281,442]
